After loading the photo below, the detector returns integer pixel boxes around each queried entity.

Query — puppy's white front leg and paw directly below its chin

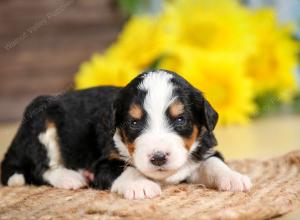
[111,167,161,199]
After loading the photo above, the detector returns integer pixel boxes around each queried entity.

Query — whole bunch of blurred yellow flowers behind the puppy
[75,0,296,124]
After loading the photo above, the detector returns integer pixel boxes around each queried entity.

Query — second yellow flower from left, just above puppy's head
[106,16,172,71]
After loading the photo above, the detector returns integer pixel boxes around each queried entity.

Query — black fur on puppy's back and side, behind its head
[1,87,123,187]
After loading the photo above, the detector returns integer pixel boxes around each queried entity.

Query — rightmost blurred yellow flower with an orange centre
[247,10,297,101]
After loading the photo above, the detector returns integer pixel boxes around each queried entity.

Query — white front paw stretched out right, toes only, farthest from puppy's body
[215,170,252,192]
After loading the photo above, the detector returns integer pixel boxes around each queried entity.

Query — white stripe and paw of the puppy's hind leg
[39,123,87,189]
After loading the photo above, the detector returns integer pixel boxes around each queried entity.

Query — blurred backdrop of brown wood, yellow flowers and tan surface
[0,0,300,159]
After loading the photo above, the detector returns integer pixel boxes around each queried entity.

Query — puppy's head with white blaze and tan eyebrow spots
[114,70,218,179]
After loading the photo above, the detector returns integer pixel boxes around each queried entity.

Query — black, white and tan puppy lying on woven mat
[1,70,251,199]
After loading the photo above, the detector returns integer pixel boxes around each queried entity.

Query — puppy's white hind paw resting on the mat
[43,168,87,189]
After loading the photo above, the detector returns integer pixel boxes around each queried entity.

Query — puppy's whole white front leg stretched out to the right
[189,156,252,192]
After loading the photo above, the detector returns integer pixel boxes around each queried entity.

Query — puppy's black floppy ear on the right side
[192,89,219,132]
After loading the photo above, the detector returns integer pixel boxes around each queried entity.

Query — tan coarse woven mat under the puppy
[0,151,300,220]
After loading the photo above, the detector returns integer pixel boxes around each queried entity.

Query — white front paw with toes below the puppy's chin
[111,179,161,199]
